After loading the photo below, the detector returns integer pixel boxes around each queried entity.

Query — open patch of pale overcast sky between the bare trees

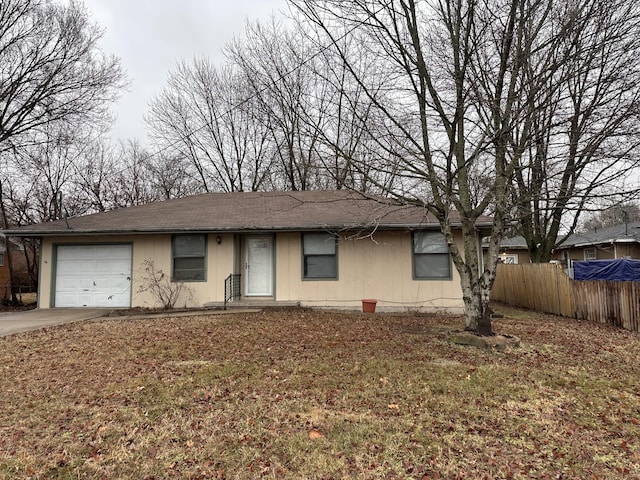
[84,0,288,142]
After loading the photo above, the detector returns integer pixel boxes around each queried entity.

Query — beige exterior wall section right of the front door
[276,232,463,311]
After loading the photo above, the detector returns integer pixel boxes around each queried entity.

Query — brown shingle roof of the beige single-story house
[6,190,491,236]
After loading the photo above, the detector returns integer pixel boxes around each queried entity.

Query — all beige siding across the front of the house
[38,232,463,311]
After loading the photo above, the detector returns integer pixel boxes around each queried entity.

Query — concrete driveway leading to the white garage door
[0,308,109,337]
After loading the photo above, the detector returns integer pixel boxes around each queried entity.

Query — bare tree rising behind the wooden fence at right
[513,0,640,262]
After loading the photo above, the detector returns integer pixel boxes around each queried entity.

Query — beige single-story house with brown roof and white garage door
[2,191,491,311]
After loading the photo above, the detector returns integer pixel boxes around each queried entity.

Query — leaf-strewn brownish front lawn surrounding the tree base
[0,310,640,479]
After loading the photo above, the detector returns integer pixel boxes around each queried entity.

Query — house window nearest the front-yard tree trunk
[413,232,451,279]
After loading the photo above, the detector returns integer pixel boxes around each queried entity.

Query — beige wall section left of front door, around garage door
[38,234,234,308]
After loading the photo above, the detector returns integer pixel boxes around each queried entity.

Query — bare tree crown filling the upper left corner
[0,0,123,150]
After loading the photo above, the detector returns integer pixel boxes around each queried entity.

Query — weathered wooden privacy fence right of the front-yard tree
[491,263,640,332]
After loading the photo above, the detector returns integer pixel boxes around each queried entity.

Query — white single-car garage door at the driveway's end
[55,245,131,307]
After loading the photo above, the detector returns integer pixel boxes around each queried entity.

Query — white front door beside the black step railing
[244,237,273,297]
